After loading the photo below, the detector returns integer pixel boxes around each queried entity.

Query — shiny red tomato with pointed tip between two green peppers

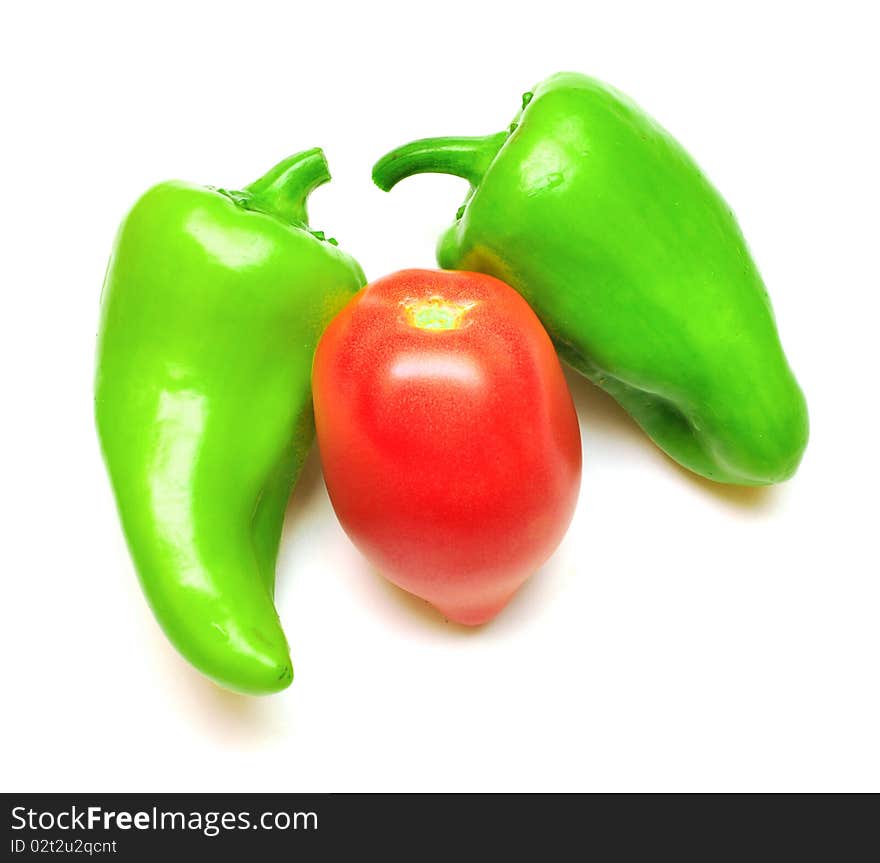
[313,270,581,624]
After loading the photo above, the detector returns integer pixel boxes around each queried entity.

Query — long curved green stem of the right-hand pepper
[373,132,507,192]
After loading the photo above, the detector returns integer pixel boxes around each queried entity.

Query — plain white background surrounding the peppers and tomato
[0,0,880,791]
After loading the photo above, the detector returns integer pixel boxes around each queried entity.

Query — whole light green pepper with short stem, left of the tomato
[95,150,365,694]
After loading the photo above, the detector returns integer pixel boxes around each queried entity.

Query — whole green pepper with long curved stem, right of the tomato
[373,73,808,485]
